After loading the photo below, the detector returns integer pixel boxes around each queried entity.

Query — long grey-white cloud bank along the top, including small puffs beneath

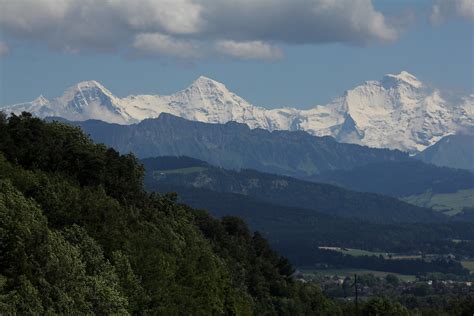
[0,0,399,60]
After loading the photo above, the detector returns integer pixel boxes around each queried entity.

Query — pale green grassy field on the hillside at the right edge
[402,189,474,216]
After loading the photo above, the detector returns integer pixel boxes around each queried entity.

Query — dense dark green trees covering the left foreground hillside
[0,114,340,315]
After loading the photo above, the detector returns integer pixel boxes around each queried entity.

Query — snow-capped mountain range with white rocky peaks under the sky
[3,71,474,153]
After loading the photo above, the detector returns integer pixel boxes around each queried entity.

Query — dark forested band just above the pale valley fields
[147,184,474,260]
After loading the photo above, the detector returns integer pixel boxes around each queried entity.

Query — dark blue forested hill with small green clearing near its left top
[141,157,446,223]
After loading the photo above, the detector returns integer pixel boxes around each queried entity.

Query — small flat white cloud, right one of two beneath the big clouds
[215,40,284,60]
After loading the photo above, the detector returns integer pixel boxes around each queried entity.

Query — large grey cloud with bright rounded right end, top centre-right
[202,0,398,45]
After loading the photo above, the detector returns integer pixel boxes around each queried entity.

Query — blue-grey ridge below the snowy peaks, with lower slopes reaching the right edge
[50,113,474,196]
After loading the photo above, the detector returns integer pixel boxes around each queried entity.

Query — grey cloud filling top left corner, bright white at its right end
[0,0,202,52]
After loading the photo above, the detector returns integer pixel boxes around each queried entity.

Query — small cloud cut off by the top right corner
[430,0,474,24]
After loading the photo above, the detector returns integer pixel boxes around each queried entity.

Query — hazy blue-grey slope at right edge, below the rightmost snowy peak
[415,135,474,170]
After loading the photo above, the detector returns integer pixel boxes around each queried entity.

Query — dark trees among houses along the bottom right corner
[320,273,474,316]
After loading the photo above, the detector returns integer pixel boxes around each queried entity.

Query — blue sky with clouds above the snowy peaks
[0,0,474,108]
